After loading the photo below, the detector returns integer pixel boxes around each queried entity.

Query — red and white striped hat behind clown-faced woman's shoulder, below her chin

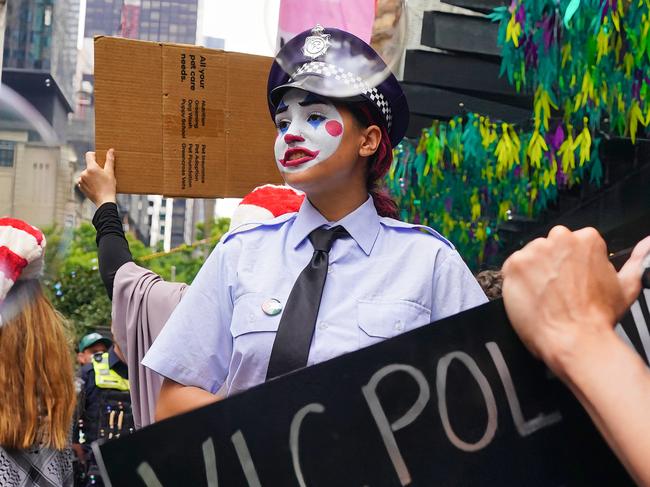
[230,184,305,234]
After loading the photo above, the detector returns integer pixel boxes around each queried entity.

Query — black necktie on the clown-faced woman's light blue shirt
[266,226,350,380]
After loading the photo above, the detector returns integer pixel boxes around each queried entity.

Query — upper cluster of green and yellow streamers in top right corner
[489,0,650,142]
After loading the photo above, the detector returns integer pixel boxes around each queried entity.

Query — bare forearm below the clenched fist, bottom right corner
[559,331,650,486]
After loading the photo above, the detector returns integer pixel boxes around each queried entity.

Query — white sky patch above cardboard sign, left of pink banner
[202,0,280,56]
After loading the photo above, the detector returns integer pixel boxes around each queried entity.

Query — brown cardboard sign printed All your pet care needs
[95,37,282,197]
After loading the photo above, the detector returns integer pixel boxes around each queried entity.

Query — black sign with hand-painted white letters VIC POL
[100,298,650,487]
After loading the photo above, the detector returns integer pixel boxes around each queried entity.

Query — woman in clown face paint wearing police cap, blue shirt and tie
[143,26,486,419]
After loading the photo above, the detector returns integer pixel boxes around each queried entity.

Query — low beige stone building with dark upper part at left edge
[0,70,80,227]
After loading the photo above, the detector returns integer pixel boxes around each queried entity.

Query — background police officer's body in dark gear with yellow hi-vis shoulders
[73,345,134,487]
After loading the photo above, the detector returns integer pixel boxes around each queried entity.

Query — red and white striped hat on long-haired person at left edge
[0,218,45,303]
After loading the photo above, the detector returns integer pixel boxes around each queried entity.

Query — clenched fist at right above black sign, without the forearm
[503,227,628,375]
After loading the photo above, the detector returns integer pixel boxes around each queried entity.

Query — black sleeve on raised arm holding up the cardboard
[93,203,133,299]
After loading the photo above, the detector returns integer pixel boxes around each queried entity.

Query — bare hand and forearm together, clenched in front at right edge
[503,227,650,485]
